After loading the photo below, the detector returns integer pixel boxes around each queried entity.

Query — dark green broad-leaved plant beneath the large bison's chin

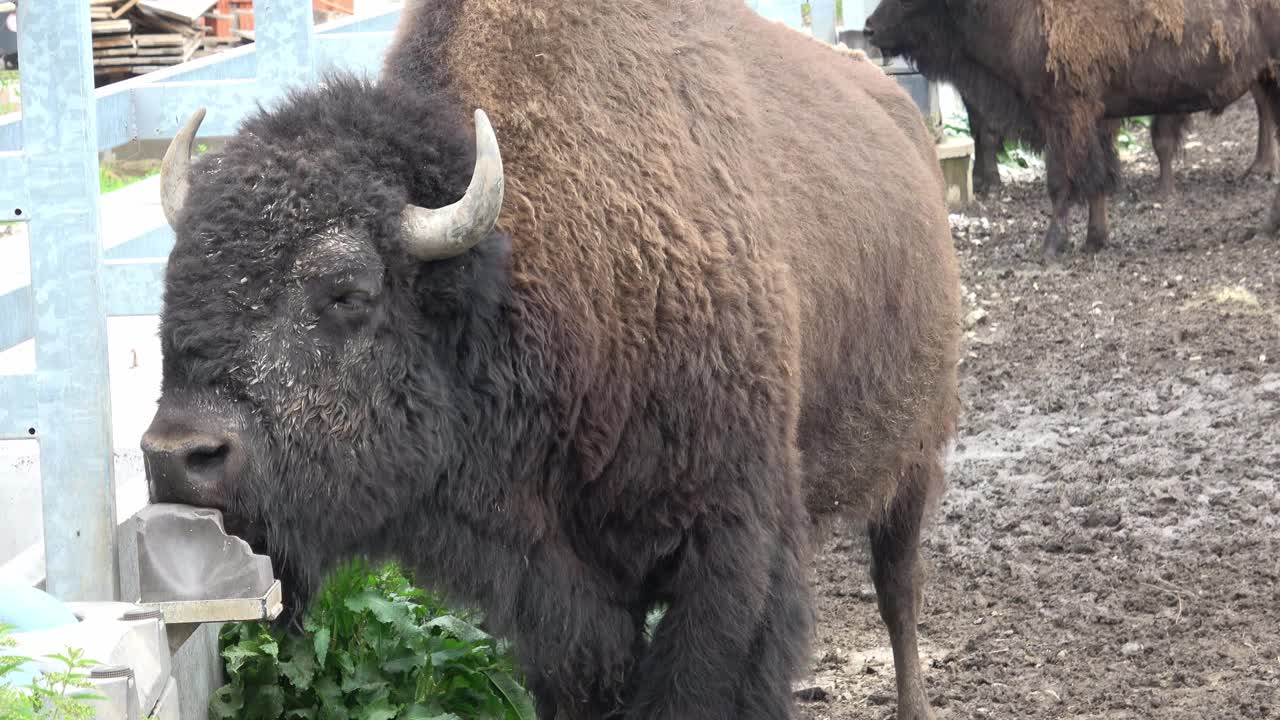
[209,561,536,720]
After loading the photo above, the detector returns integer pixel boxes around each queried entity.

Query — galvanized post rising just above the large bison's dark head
[253,0,315,97]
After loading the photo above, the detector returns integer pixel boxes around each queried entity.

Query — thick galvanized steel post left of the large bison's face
[18,0,118,601]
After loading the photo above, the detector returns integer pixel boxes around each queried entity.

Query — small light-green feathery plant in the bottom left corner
[0,624,105,720]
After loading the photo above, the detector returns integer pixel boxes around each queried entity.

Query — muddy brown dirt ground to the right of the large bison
[799,96,1280,720]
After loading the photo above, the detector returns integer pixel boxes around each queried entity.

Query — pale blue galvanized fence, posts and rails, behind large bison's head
[0,0,399,601]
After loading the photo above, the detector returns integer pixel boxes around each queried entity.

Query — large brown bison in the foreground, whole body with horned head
[142,0,960,720]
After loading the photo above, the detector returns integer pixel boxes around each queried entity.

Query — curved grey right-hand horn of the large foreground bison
[401,110,503,260]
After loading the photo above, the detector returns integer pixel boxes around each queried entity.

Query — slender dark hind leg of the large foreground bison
[868,462,942,720]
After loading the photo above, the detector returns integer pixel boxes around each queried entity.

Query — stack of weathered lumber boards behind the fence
[87,0,214,82]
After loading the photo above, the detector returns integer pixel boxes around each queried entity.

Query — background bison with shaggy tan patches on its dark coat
[867,0,1280,255]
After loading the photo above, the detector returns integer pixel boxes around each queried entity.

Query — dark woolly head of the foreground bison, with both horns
[142,78,508,610]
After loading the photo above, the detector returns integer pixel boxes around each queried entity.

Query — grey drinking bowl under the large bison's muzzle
[132,503,283,628]
